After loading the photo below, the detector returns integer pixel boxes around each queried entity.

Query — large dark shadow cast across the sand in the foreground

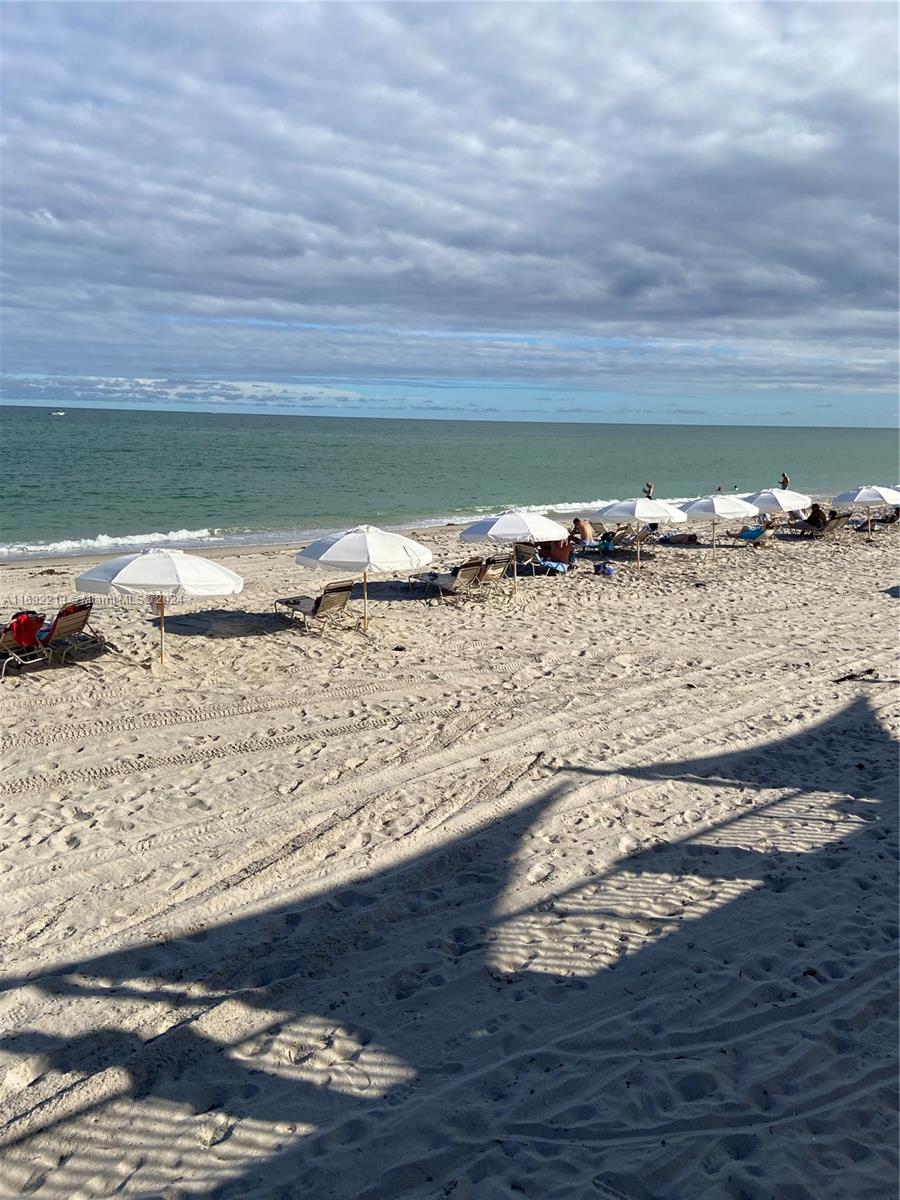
[0,701,898,1200]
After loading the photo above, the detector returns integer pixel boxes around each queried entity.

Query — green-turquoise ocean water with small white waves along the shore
[0,406,900,558]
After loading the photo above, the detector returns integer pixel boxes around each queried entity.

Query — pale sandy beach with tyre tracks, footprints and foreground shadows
[0,528,900,1200]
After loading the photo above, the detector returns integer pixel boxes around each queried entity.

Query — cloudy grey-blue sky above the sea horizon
[0,0,898,425]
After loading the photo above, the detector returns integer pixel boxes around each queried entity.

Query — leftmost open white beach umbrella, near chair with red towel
[76,546,244,662]
